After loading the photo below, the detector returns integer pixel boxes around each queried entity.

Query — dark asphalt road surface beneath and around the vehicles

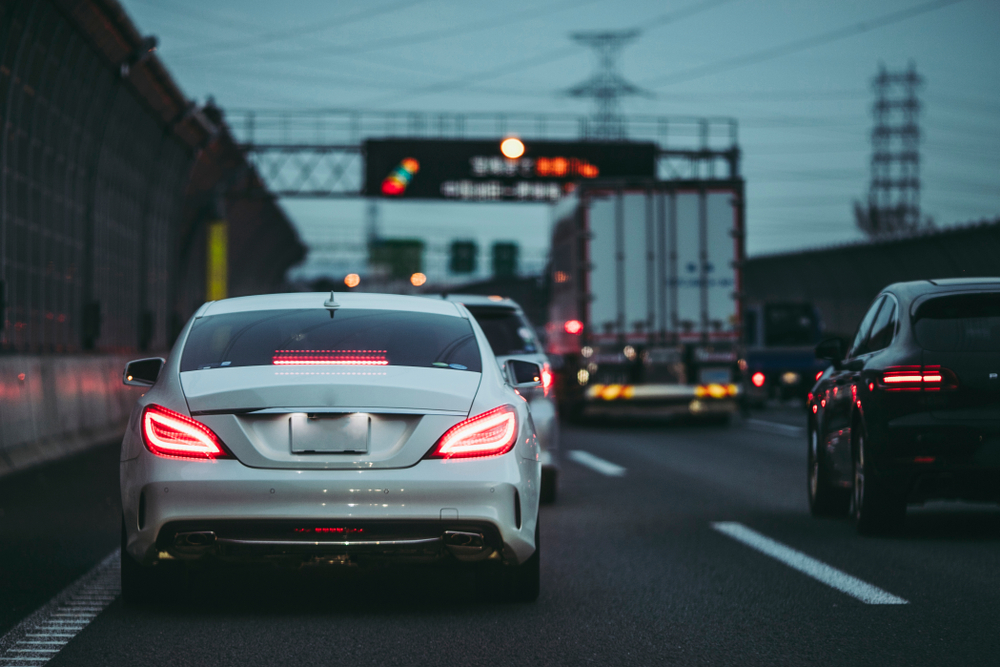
[0,410,1000,666]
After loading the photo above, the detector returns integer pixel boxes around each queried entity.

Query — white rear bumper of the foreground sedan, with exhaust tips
[121,452,541,563]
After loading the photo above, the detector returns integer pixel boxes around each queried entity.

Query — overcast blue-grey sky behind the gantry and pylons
[123,0,1000,282]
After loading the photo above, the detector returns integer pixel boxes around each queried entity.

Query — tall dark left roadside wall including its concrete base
[0,0,305,474]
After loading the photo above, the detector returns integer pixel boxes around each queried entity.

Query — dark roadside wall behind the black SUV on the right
[743,219,1000,338]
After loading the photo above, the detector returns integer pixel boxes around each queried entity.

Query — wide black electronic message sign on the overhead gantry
[365,137,656,202]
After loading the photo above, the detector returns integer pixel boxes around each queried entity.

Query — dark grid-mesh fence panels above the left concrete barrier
[0,0,203,352]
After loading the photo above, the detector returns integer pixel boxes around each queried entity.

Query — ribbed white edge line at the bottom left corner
[0,549,121,665]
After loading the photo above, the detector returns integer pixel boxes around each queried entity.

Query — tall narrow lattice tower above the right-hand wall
[856,63,923,237]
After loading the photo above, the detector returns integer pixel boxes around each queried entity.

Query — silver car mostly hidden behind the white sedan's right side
[444,294,559,503]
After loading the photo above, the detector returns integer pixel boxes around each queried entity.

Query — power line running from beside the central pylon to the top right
[641,0,963,86]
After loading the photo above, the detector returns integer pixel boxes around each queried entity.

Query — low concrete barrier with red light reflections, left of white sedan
[0,355,143,476]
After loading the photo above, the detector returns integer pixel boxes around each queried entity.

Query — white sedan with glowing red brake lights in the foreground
[121,293,542,602]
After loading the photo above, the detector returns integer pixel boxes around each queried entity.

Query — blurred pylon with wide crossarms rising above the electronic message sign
[567,30,649,141]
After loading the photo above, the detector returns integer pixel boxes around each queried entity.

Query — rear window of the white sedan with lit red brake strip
[181,308,483,373]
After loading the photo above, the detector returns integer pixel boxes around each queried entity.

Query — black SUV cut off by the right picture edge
[808,278,1000,534]
